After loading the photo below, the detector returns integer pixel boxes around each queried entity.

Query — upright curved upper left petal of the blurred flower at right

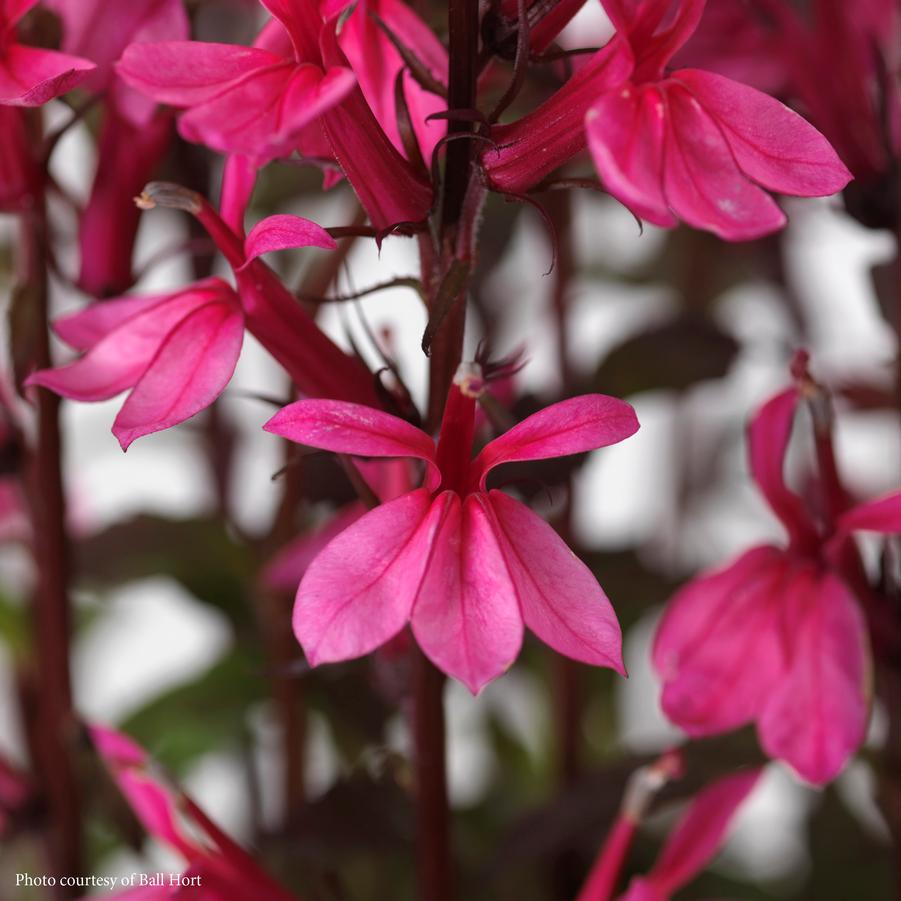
[748,388,814,540]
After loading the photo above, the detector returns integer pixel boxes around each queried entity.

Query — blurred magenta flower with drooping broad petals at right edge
[653,380,901,784]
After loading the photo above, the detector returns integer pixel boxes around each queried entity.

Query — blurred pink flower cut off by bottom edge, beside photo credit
[90,726,297,901]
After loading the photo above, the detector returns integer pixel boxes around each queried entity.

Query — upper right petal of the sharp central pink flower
[472,394,638,488]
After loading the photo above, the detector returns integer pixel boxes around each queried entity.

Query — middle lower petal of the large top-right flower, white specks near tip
[664,80,786,241]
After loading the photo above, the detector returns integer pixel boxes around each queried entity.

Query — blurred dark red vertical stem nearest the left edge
[21,196,81,898]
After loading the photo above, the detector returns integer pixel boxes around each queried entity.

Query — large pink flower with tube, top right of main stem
[483,0,850,240]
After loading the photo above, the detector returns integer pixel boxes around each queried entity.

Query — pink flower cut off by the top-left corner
[0,0,94,106]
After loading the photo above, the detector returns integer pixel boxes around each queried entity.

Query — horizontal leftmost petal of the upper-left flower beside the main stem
[116,41,285,106]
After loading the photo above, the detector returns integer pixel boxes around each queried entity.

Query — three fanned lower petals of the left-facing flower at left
[26,278,244,450]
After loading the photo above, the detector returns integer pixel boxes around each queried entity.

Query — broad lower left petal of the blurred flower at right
[653,547,788,736]
